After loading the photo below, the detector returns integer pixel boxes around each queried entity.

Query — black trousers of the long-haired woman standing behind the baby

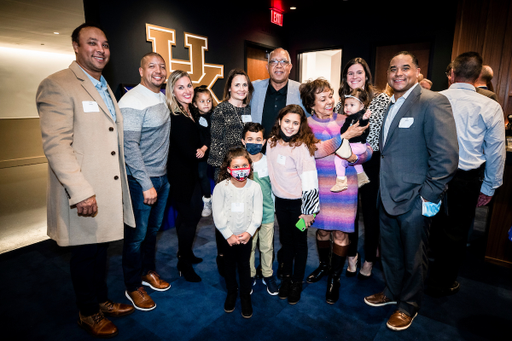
[347,151,380,262]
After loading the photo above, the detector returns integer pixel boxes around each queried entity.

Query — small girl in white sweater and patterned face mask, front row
[212,147,263,318]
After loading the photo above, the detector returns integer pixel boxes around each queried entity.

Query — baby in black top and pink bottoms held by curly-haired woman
[331,88,371,192]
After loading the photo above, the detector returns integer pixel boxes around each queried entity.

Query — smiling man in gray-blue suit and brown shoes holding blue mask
[364,51,458,330]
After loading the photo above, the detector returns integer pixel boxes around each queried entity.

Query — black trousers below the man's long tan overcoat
[70,243,109,316]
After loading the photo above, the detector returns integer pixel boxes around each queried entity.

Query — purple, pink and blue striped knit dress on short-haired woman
[308,113,372,233]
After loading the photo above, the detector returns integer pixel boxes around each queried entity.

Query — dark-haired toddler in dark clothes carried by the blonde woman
[190,85,214,217]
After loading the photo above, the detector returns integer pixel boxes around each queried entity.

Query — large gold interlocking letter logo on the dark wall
[146,24,224,104]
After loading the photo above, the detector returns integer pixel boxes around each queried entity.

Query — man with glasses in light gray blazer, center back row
[251,48,306,138]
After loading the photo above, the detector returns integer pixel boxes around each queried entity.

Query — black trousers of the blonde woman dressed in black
[173,181,203,257]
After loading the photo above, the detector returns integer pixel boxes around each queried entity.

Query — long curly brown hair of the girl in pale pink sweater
[268,104,320,156]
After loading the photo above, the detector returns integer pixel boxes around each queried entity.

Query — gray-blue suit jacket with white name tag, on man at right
[379,86,459,215]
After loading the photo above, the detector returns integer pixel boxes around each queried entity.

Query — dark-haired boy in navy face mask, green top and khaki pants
[242,122,279,296]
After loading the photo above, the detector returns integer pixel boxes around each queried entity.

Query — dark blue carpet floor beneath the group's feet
[0,217,512,341]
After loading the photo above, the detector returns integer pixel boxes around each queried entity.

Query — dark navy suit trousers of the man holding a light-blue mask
[379,195,432,316]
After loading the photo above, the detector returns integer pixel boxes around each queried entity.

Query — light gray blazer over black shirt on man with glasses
[251,78,308,123]
